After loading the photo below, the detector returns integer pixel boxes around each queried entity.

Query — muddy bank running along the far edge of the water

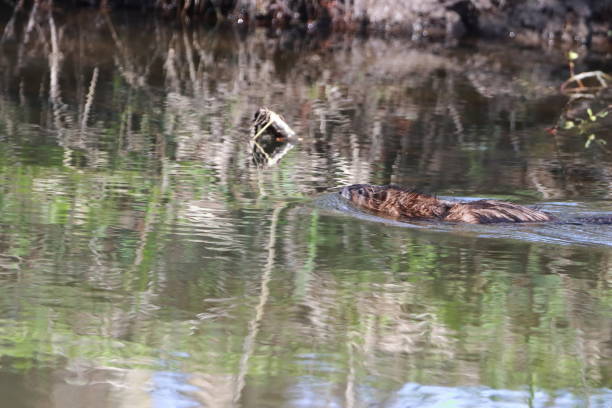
[0,0,612,48]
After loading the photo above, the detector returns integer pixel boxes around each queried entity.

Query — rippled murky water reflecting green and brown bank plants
[0,11,612,408]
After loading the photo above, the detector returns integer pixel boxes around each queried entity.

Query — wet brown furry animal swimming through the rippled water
[340,184,552,224]
